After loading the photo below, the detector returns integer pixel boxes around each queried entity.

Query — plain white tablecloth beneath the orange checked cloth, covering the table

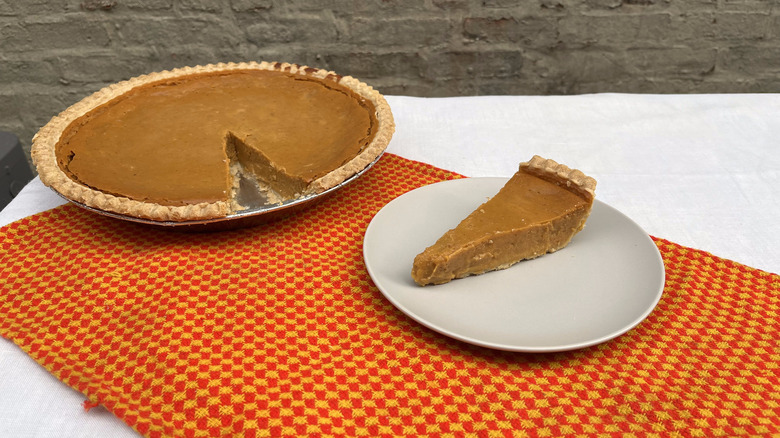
[0,94,780,437]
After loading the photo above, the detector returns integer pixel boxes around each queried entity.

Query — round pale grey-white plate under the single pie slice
[363,178,665,352]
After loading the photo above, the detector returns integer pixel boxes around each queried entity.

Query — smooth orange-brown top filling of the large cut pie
[56,70,376,205]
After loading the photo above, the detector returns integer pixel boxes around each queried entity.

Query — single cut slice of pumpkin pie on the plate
[412,155,596,286]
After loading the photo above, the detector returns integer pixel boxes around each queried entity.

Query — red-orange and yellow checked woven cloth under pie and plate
[0,154,780,437]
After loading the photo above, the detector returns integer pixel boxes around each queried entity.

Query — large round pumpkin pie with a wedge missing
[32,62,394,221]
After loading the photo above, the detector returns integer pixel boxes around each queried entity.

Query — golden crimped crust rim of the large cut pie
[32,62,395,221]
